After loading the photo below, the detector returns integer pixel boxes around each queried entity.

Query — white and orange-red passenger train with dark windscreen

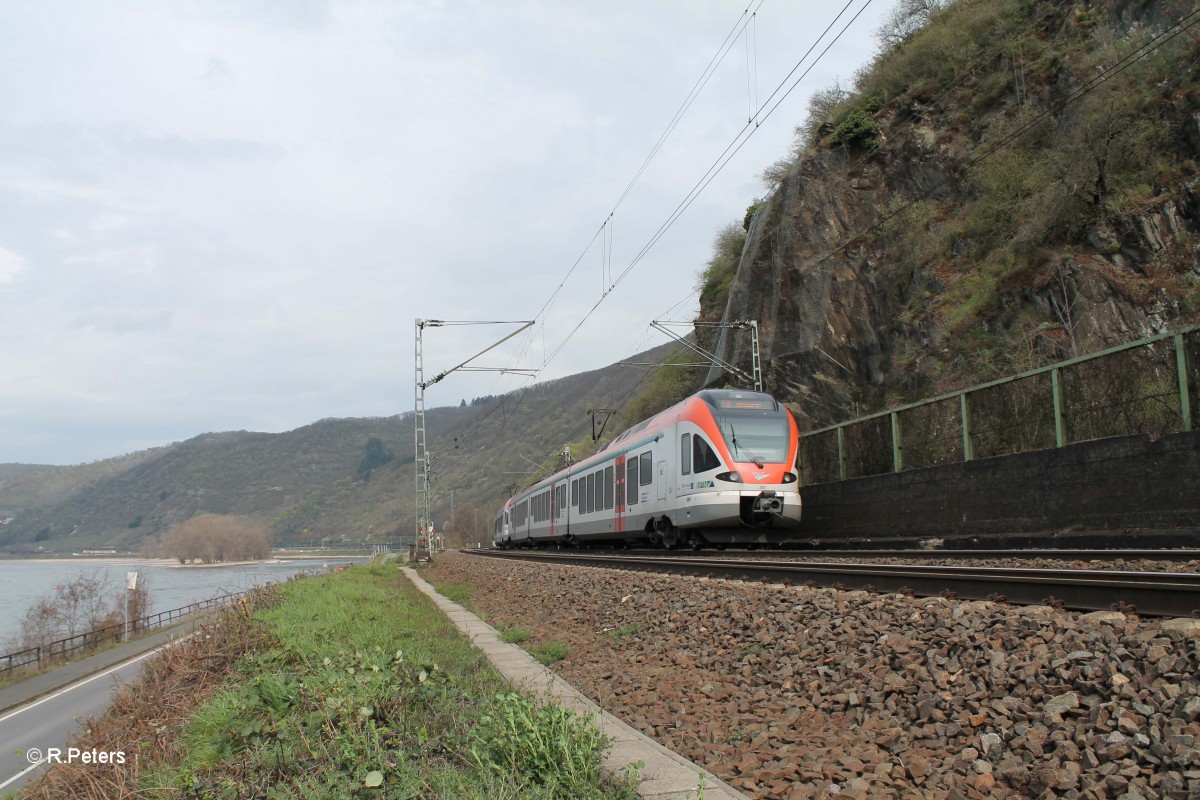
[492,390,800,549]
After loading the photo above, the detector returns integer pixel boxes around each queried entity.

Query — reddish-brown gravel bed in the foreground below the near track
[427,553,1200,800]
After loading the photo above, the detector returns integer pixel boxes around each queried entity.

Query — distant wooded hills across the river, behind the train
[0,347,668,552]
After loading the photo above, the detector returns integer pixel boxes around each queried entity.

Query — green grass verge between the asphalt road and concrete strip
[21,565,636,800]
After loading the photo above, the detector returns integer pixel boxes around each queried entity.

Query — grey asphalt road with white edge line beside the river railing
[0,644,169,792]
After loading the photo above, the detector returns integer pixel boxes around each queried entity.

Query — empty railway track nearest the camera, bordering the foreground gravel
[464,551,1200,616]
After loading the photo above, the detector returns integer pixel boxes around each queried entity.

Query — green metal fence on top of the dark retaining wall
[798,325,1200,485]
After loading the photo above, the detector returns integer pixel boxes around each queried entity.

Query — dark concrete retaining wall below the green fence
[802,432,1200,547]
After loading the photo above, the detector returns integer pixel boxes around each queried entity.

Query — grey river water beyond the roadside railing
[0,558,365,654]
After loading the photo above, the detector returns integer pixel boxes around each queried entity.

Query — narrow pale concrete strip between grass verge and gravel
[402,567,746,800]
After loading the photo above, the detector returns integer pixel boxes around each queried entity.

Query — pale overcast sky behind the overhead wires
[0,0,892,464]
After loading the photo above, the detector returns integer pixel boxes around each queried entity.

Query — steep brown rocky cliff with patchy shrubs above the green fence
[706,1,1200,427]
